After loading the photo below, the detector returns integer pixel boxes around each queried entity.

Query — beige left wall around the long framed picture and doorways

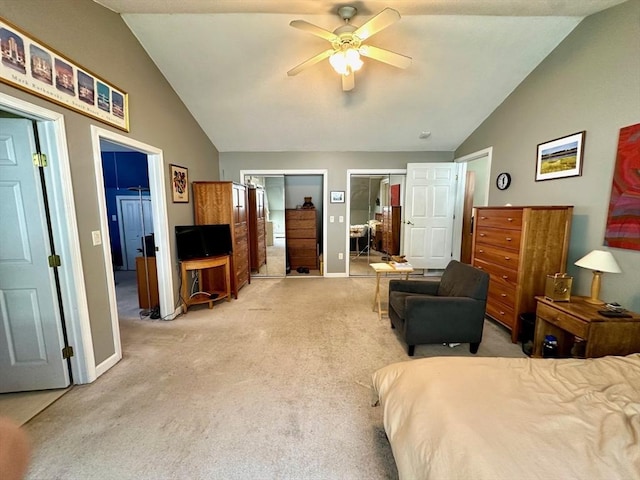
[0,0,218,364]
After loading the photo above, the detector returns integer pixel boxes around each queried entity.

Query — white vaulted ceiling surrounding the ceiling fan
[95,0,624,152]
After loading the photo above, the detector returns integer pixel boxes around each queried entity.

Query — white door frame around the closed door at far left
[0,92,97,384]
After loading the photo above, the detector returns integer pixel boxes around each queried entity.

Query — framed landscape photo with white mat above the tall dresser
[536,131,586,182]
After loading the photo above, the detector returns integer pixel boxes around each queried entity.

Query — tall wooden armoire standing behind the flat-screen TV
[192,182,250,298]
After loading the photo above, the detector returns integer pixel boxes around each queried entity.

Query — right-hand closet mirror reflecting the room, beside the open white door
[347,170,406,276]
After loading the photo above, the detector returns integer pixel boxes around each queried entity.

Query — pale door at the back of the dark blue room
[118,197,153,270]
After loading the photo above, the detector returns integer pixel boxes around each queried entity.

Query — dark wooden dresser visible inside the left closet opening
[285,208,319,270]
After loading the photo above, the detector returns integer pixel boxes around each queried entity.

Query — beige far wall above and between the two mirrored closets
[220,152,453,274]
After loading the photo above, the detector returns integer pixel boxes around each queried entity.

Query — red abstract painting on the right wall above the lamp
[604,123,640,250]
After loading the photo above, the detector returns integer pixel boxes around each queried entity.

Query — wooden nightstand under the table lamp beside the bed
[533,297,640,358]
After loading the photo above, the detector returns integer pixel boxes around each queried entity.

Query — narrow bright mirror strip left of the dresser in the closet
[244,175,286,277]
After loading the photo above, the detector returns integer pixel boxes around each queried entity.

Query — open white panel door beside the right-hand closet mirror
[403,163,459,269]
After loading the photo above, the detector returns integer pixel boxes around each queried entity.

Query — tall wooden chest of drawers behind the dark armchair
[471,206,573,343]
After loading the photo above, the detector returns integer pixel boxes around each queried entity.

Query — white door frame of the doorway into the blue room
[91,125,180,375]
